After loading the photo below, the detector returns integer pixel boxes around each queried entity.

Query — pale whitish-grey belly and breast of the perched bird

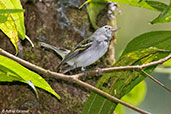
[75,43,108,67]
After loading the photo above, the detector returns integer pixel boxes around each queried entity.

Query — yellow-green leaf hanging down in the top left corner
[0,0,25,52]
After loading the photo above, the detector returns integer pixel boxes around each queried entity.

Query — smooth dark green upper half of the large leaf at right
[122,31,171,56]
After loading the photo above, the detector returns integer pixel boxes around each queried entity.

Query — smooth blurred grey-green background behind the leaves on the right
[116,0,171,114]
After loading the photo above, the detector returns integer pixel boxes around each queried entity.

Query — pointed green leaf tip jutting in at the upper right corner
[151,2,171,24]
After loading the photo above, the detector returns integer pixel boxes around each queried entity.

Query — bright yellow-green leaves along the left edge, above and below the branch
[0,0,60,99]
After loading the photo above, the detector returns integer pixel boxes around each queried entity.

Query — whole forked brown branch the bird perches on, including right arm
[0,48,171,114]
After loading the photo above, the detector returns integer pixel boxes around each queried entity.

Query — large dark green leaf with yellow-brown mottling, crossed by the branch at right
[83,31,171,114]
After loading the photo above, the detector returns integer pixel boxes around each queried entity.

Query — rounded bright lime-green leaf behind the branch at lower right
[115,81,146,114]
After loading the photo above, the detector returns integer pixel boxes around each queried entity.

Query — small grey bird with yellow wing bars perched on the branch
[57,25,118,73]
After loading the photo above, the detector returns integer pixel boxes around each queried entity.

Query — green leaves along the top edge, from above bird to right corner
[80,0,171,29]
